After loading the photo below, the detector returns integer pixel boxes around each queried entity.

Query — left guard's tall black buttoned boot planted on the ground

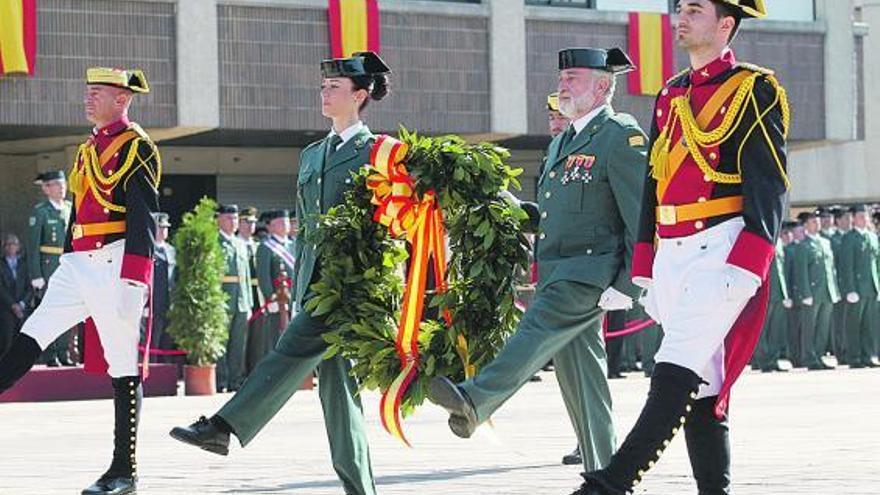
[82,376,143,495]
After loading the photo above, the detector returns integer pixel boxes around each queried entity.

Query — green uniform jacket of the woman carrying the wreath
[294,126,375,305]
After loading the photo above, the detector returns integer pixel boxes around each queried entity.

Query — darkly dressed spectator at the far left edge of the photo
[0,234,31,357]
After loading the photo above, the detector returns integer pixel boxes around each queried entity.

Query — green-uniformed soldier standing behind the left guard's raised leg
[27,170,76,366]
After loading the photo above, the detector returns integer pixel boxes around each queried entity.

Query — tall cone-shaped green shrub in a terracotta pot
[167,198,229,395]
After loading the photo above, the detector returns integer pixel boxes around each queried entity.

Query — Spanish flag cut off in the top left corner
[0,0,37,76]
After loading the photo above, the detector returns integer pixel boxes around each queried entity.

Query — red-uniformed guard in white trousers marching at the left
[0,68,161,495]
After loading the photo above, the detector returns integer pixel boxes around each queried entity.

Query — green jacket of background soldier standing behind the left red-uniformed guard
[27,200,71,281]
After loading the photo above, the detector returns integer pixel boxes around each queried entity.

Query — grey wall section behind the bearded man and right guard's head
[526,20,825,140]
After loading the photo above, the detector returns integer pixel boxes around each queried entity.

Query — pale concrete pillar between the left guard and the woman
[176,0,220,128]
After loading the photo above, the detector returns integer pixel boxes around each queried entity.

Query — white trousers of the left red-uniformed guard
[21,241,141,378]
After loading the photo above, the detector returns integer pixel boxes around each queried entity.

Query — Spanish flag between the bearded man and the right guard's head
[629,12,675,95]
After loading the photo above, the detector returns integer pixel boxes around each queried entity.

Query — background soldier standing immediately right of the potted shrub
[217,205,253,392]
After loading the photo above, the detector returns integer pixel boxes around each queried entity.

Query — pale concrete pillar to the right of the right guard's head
[816,0,856,141]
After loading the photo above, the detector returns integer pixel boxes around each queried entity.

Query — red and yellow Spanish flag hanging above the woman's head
[327,0,379,58]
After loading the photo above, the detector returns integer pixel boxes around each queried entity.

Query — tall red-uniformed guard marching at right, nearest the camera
[575,0,789,495]
